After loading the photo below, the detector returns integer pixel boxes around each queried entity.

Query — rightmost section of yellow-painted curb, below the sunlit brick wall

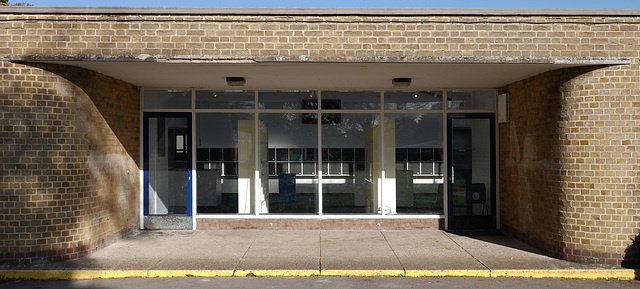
[491,269,636,279]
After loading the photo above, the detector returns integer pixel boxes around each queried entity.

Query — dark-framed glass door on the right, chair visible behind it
[447,114,496,229]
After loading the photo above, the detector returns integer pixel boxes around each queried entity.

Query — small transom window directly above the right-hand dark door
[447,90,495,110]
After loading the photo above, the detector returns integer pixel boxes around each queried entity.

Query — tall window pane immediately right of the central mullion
[322,113,381,214]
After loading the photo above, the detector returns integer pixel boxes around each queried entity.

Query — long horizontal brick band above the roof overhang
[0,14,640,62]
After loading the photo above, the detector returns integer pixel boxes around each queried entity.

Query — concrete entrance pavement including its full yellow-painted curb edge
[0,230,635,279]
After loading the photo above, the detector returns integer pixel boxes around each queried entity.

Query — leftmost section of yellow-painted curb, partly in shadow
[0,270,147,280]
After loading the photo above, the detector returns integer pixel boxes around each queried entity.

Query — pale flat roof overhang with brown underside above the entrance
[11,55,631,90]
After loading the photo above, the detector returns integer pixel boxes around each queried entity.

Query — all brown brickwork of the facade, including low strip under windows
[0,8,640,264]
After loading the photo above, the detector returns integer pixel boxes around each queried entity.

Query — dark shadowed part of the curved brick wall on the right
[498,65,620,264]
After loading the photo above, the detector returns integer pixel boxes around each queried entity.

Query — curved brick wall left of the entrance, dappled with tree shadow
[0,61,139,266]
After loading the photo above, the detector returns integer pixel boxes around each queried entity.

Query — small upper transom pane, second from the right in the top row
[384,91,442,110]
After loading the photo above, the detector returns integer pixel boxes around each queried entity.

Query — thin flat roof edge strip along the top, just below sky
[0,6,640,16]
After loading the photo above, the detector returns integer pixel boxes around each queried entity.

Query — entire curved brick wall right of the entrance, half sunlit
[499,64,640,265]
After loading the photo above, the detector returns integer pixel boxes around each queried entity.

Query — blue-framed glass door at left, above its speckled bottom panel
[144,113,191,216]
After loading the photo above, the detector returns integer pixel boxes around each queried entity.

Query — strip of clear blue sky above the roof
[20,0,640,9]
